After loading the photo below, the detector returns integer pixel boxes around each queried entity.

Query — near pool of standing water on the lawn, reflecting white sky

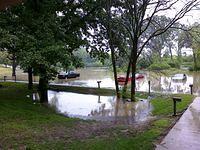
[48,91,152,124]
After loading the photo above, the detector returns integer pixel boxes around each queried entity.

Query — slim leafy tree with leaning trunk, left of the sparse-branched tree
[83,0,130,97]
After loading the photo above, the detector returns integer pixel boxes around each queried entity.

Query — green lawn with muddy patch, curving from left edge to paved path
[0,83,193,150]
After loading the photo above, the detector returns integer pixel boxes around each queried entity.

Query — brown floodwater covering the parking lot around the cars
[52,68,200,95]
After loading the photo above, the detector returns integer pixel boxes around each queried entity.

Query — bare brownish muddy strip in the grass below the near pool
[27,120,156,143]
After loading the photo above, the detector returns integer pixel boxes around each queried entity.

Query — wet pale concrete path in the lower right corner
[156,97,200,150]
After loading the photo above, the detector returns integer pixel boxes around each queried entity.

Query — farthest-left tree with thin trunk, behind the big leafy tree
[0,8,21,76]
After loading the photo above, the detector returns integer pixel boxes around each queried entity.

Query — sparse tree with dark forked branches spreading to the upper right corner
[111,0,199,100]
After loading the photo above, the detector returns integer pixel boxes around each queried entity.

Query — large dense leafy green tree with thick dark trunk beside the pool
[0,0,99,102]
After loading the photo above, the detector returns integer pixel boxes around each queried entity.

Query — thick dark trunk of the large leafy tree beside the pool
[39,66,48,103]
